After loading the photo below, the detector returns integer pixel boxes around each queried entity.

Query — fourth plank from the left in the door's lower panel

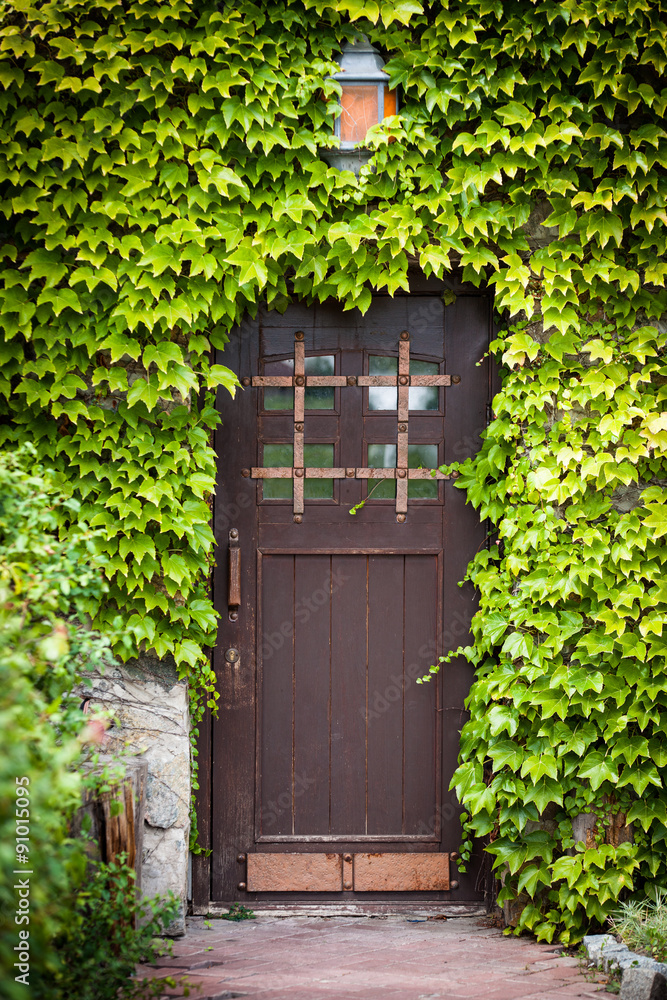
[367,555,405,835]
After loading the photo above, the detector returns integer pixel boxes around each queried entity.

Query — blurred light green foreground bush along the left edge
[0,447,115,996]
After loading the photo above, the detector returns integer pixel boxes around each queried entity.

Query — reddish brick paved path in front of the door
[139,916,611,1000]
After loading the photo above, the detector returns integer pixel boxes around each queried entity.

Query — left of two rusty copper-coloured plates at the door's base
[248,854,343,892]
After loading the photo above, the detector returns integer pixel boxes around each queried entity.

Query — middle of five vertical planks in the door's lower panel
[331,555,368,836]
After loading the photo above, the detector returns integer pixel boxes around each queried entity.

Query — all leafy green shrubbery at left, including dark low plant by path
[0,447,171,1000]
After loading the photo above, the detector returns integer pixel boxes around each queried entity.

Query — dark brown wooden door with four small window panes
[200,291,490,904]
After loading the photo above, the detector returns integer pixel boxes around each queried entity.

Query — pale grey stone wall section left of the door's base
[80,655,190,937]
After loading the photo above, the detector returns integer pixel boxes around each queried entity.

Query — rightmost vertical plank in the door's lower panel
[403,555,440,836]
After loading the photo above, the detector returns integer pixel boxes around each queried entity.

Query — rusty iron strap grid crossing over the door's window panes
[241,330,461,523]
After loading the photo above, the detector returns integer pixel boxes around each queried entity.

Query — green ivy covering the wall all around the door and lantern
[0,0,667,936]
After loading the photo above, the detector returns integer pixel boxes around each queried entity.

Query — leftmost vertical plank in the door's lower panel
[257,555,294,837]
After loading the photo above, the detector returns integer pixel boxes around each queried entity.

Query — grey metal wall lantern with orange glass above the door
[322,35,397,174]
